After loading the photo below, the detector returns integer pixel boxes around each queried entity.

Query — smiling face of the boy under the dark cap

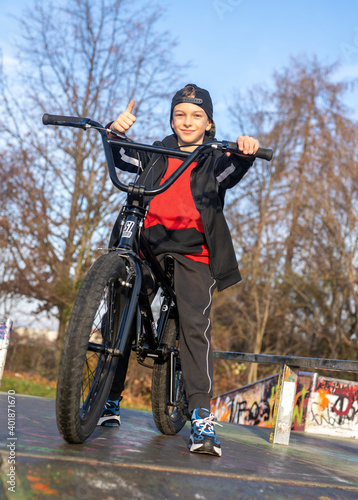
[171,102,211,150]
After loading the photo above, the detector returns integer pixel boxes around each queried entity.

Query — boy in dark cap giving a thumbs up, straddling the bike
[98,84,259,456]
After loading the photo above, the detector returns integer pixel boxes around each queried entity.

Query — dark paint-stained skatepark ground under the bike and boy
[0,393,358,500]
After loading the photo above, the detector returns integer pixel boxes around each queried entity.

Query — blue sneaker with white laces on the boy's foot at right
[188,408,222,457]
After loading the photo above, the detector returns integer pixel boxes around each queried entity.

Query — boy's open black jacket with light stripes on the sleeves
[111,134,253,291]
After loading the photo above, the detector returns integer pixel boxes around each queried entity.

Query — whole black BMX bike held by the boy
[43,113,272,444]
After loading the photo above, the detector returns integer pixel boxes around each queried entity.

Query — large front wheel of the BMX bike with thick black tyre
[56,252,131,444]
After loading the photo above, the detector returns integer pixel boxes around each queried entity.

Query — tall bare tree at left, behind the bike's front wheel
[0,0,180,342]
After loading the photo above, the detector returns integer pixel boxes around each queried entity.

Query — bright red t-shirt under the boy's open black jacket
[144,158,209,264]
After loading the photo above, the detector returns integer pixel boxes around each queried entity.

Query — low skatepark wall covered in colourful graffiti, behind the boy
[211,372,358,438]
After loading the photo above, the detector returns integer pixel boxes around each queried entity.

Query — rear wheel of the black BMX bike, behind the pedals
[152,318,190,436]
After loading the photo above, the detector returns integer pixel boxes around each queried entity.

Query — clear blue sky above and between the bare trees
[0,0,358,328]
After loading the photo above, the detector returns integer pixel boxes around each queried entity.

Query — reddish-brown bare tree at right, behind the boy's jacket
[213,59,358,381]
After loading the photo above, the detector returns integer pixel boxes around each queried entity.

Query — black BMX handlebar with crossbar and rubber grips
[42,113,273,196]
